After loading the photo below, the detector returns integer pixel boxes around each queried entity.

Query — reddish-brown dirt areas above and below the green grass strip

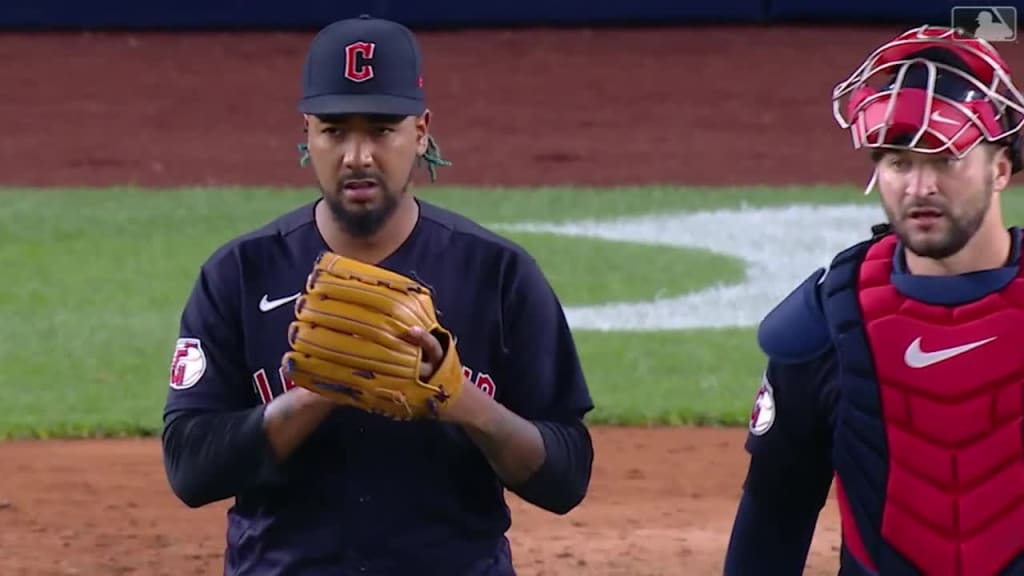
[9,28,1024,576]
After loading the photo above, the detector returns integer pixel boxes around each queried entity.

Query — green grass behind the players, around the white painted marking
[0,188,1024,438]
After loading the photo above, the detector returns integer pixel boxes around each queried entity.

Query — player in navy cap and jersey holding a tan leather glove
[163,17,594,576]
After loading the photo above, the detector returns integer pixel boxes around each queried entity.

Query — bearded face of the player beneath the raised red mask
[878,145,1010,259]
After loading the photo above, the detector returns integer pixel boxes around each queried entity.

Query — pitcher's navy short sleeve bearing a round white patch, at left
[164,257,256,417]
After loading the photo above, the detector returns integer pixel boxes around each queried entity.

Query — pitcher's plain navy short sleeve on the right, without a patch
[498,249,594,421]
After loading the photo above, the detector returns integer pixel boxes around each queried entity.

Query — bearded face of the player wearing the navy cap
[306,112,429,237]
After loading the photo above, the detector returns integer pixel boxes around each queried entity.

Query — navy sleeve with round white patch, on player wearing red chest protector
[745,351,836,496]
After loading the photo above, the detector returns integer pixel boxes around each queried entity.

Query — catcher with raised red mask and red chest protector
[724,26,1024,576]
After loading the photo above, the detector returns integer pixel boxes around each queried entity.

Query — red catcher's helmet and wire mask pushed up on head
[833,26,1024,194]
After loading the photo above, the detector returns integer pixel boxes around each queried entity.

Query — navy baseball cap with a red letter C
[299,14,426,116]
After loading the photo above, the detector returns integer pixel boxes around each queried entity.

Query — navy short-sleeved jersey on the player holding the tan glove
[159,200,593,574]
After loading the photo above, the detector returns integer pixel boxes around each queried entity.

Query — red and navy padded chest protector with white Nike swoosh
[821,236,1024,576]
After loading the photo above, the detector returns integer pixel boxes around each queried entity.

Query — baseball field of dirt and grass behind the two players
[6,28,1024,576]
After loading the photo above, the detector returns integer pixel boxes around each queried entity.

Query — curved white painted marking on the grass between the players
[490,205,885,332]
